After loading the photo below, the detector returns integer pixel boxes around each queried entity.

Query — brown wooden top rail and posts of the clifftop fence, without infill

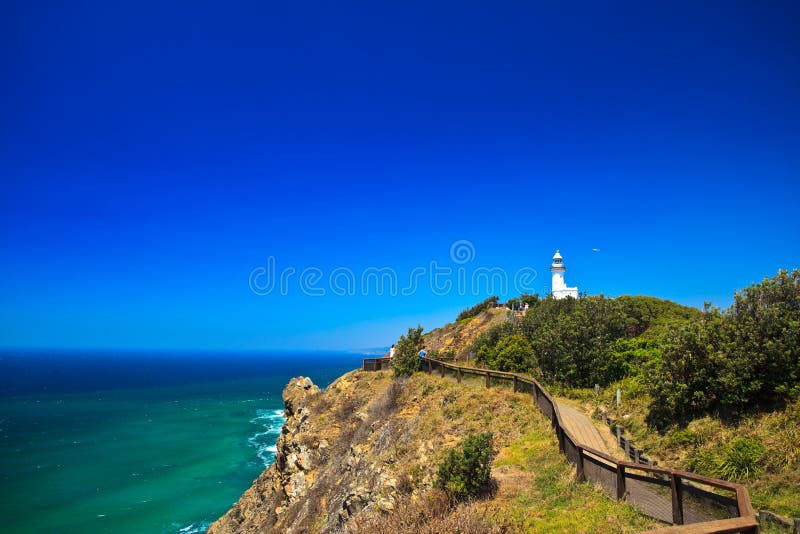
[364,357,758,534]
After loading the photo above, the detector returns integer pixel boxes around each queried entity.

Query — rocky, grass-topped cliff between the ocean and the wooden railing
[209,371,656,534]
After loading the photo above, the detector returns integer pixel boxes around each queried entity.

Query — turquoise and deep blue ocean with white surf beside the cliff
[0,352,363,533]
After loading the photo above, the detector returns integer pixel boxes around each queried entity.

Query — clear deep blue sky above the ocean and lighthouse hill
[0,1,800,349]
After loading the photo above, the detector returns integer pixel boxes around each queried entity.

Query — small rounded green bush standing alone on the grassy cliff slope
[435,432,494,500]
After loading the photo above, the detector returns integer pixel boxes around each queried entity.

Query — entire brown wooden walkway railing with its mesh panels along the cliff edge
[363,358,758,534]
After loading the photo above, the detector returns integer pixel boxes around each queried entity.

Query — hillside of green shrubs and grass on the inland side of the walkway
[416,270,800,517]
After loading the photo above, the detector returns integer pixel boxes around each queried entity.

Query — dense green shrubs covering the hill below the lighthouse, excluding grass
[472,270,800,429]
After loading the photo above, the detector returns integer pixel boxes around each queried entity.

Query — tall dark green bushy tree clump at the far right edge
[648,270,800,429]
